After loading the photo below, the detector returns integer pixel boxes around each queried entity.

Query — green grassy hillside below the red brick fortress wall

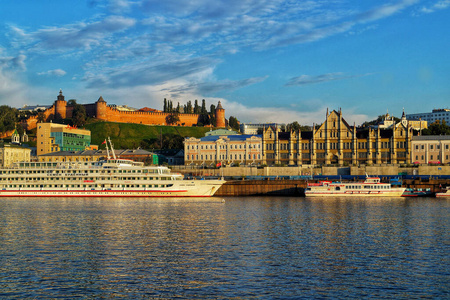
[85,122,214,150]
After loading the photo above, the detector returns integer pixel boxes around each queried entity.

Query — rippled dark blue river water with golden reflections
[0,197,450,299]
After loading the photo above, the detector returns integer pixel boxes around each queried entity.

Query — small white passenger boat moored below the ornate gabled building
[305,177,405,197]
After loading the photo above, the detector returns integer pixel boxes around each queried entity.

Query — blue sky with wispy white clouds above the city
[0,0,450,125]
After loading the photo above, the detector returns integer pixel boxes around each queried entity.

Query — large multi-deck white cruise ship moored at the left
[0,138,225,197]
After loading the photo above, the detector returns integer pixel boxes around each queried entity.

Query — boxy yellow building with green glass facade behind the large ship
[36,123,91,156]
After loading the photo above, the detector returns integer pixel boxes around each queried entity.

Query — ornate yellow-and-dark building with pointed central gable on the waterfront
[262,110,412,166]
